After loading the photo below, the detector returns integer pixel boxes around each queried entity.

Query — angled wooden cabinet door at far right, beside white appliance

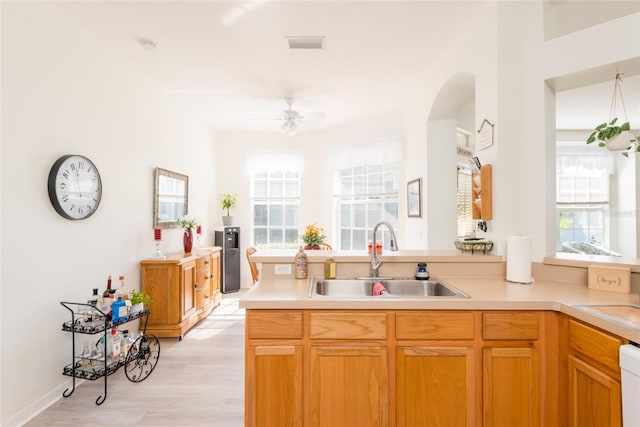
[569,356,622,427]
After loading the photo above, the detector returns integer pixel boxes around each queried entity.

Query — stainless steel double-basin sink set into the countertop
[309,277,469,298]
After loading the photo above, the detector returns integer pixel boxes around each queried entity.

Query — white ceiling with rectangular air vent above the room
[55,0,640,131]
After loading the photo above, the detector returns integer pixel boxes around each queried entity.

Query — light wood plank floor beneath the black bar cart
[26,291,245,427]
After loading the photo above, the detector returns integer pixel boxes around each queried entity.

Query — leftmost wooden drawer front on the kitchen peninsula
[246,311,302,339]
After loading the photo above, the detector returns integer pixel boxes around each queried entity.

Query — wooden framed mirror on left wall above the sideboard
[153,168,189,228]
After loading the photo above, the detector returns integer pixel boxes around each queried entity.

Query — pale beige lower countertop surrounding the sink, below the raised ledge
[240,278,640,343]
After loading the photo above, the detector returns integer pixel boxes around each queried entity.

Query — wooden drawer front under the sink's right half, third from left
[396,312,474,340]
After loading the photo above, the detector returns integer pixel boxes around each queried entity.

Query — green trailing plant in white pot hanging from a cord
[587,73,640,157]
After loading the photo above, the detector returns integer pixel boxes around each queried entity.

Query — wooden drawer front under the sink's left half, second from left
[310,312,388,340]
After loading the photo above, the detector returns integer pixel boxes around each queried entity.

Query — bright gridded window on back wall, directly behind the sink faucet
[334,162,398,251]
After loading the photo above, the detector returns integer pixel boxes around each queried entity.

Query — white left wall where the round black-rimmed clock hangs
[0,2,216,425]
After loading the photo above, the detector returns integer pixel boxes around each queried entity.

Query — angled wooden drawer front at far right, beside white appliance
[569,320,623,371]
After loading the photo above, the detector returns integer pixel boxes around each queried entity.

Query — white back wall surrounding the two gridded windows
[215,113,402,272]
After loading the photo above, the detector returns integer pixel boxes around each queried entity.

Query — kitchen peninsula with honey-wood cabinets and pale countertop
[240,251,640,426]
